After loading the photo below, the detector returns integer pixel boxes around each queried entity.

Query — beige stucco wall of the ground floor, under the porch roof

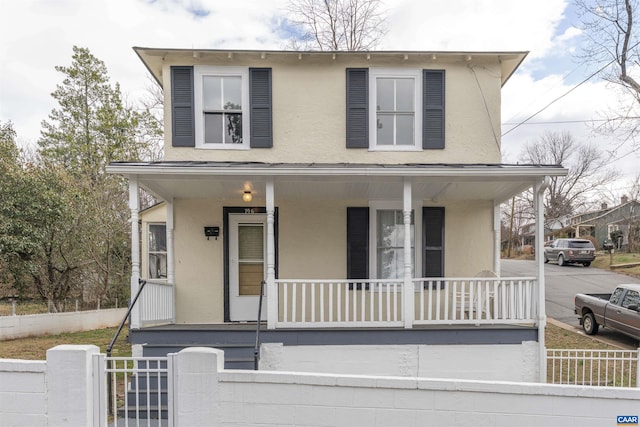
[165,199,493,323]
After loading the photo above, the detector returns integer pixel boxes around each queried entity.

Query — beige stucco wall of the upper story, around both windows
[163,57,501,163]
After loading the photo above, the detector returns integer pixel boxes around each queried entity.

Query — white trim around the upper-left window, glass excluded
[193,65,251,150]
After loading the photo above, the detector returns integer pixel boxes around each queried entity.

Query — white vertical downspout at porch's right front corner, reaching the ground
[534,176,551,383]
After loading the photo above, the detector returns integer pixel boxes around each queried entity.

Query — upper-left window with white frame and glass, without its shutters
[194,66,249,149]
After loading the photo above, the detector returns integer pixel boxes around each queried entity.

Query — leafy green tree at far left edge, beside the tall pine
[0,123,83,311]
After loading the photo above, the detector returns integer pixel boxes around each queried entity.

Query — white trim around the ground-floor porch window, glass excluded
[369,200,422,280]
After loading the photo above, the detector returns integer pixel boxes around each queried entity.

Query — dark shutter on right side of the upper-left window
[249,68,273,148]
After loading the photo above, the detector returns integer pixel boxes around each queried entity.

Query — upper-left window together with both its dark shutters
[171,66,273,149]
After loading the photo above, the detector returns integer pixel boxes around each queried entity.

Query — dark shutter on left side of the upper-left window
[171,67,196,147]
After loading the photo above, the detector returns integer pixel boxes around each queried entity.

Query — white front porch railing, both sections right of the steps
[270,277,537,328]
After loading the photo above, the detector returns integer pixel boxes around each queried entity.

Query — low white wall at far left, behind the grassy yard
[0,307,127,341]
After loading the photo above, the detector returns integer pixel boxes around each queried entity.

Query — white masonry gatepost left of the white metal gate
[47,345,100,427]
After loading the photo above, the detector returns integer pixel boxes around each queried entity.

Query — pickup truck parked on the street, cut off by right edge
[574,284,640,340]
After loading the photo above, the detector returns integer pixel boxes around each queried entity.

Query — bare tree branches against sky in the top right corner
[575,0,640,155]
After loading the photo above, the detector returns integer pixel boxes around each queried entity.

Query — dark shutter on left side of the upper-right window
[347,68,369,148]
